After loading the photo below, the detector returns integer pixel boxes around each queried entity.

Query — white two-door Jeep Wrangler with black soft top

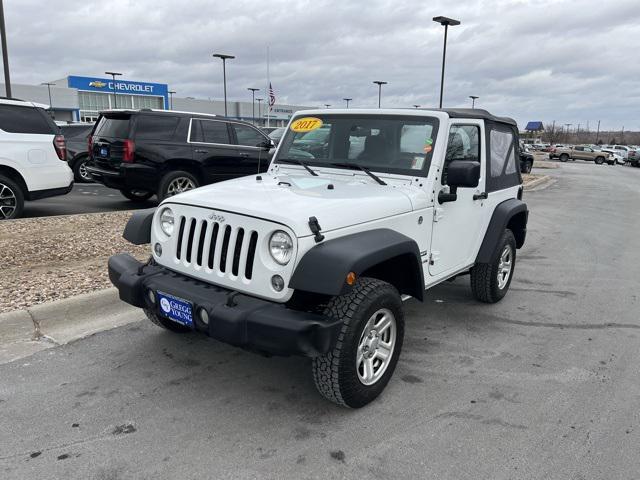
[109,109,528,408]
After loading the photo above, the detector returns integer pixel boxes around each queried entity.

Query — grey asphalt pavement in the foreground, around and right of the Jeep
[0,164,640,480]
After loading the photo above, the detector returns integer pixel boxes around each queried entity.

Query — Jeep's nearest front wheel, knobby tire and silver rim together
[312,277,404,408]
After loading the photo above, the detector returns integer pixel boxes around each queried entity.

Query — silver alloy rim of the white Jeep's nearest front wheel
[356,308,397,385]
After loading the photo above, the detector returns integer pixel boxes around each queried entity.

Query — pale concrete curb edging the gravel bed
[0,288,142,364]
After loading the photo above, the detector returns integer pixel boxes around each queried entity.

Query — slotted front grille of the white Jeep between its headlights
[175,216,258,280]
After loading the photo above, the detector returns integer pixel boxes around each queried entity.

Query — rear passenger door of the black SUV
[189,118,240,183]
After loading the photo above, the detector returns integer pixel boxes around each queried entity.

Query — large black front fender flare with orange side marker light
[289,228,424,300]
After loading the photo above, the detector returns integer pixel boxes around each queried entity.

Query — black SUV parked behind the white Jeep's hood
[86,109,273,201]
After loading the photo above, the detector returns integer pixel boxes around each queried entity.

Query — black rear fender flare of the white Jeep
[476,198,529,263]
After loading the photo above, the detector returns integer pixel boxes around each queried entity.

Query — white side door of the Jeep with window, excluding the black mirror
[428,120,491,276]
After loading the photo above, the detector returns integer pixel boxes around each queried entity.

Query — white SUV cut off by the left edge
[0,98,73,220]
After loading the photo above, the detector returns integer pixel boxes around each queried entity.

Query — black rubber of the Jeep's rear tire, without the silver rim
[470,229,516,303]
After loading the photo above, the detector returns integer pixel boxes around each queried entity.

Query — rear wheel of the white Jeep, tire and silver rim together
[471,229,516,303]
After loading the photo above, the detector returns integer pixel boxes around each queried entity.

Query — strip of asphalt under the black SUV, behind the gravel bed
[23,183,158,218]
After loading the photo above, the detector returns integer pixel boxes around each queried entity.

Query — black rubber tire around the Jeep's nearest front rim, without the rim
[312,277,404,408]
